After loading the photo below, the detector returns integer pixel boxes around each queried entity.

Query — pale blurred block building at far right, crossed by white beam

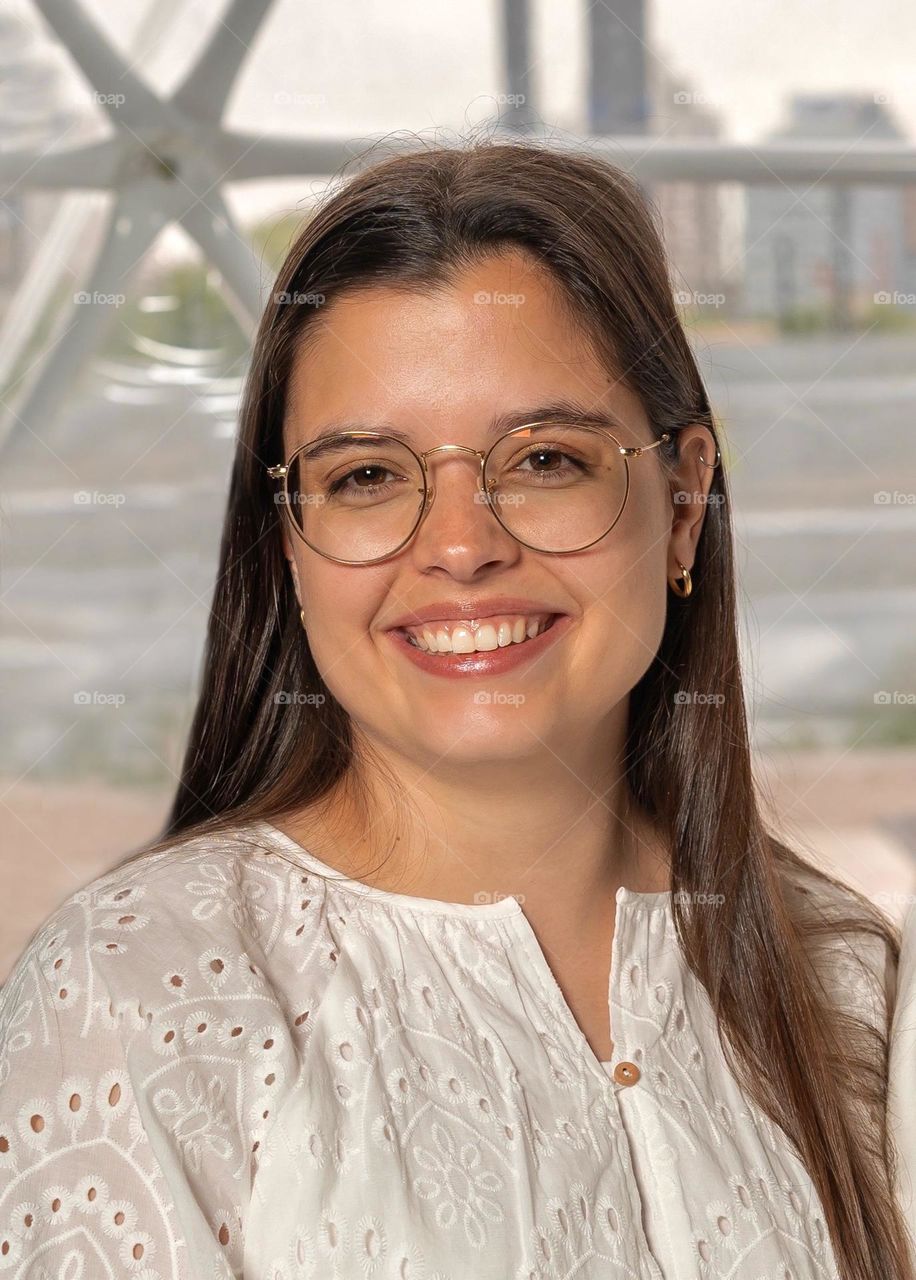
[745,95,916,328]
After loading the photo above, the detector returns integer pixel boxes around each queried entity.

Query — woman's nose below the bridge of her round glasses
[409,445,519,577]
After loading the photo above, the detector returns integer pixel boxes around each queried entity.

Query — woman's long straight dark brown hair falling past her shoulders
[123,140,911,1280]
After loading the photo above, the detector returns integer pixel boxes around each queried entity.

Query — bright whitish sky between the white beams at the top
[14,0,916,235]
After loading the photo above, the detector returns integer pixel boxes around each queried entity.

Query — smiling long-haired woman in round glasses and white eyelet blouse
[0,143,916,1280]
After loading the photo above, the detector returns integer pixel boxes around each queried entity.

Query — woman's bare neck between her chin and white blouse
[285,732,669,933]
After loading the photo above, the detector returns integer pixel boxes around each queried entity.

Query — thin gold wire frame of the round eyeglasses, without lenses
[265,419,690,564]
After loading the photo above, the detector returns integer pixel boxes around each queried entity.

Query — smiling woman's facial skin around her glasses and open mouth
[284,252,714,767]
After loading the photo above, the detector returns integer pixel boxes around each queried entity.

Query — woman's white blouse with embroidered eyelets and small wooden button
[0,823,916,1280]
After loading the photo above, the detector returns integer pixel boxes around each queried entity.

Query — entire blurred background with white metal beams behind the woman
[0,0,916,980]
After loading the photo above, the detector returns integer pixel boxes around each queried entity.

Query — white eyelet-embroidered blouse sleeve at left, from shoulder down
[0,832,318,1277]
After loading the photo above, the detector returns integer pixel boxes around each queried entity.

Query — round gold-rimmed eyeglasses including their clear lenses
[266,421,673,564]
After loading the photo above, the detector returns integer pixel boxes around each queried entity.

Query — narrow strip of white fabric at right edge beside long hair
[888,902,916,1260]
